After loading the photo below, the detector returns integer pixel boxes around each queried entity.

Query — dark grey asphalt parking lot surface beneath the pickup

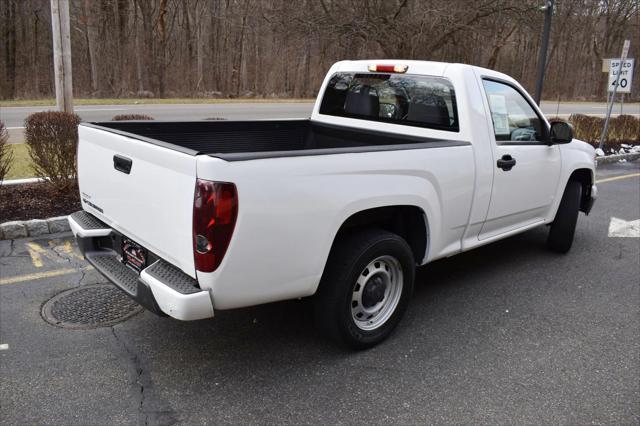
[0,161,640,425]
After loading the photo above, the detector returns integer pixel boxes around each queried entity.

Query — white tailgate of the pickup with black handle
[78,125,196,278]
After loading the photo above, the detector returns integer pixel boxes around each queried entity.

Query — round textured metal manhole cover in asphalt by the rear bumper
[42,284,144,329]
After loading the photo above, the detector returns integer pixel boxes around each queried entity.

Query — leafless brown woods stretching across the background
[0,0,640,100]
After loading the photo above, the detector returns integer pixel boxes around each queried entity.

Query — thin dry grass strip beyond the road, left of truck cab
[0,98,315,108]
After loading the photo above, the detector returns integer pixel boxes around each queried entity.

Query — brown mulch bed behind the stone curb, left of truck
[0,183,82,223]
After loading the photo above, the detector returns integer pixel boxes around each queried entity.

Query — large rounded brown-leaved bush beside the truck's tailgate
[24,111,80,190]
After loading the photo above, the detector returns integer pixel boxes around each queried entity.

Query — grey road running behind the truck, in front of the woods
[0,102,640,127]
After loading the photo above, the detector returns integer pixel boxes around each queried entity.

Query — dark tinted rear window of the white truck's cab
[320,72,460,132]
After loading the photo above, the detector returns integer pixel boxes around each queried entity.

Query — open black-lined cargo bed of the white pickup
[83,119,467,161]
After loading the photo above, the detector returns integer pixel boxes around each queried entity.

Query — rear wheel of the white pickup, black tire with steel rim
[314,229,415,349]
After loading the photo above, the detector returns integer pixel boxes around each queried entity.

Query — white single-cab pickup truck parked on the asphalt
[69,60,596,348]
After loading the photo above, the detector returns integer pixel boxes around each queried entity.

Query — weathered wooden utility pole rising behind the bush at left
[51,0,73,113]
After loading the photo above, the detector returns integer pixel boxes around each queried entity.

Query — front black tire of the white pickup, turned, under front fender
[547,181,582,253]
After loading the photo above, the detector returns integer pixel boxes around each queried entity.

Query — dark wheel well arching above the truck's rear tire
[333,206,427,264]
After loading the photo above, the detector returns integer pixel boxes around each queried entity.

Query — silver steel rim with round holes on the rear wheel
[351,255,404,331]
